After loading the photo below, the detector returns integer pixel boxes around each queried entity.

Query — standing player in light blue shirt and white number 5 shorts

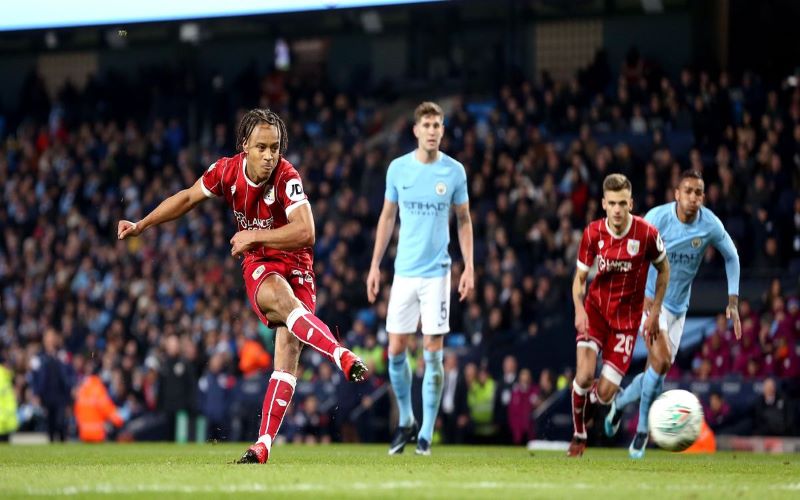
[367,102,475,455]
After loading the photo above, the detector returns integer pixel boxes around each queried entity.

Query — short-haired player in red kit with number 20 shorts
[567,174,669,457]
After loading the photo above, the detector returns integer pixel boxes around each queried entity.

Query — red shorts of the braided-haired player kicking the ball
[242,259,317,328]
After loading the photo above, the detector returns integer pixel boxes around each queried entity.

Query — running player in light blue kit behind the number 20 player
[604,170,742,458]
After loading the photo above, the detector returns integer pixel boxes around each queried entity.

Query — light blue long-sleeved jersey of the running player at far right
[644,202,739,314]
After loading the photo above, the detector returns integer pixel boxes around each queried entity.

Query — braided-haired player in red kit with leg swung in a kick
[117,109,367,463]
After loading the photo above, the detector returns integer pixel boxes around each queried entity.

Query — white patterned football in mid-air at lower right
[650,389,703,451]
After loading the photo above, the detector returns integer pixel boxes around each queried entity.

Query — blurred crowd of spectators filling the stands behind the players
[0,48,800,443]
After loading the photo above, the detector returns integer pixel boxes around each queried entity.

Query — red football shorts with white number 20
[575,301,639,385]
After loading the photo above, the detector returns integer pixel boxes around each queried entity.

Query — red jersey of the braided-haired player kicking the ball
[201,153,314,269]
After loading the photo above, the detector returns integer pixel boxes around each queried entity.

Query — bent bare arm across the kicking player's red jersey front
[231,203,316,257]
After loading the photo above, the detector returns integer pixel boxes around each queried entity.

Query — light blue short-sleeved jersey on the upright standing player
[385,151,469,278]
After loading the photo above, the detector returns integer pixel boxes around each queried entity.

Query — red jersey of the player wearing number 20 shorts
[578,215,667,331]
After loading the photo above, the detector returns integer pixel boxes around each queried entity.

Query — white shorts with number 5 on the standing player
[386,271,450,335]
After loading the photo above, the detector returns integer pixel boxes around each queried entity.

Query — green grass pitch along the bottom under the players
[0,444,800,500]
